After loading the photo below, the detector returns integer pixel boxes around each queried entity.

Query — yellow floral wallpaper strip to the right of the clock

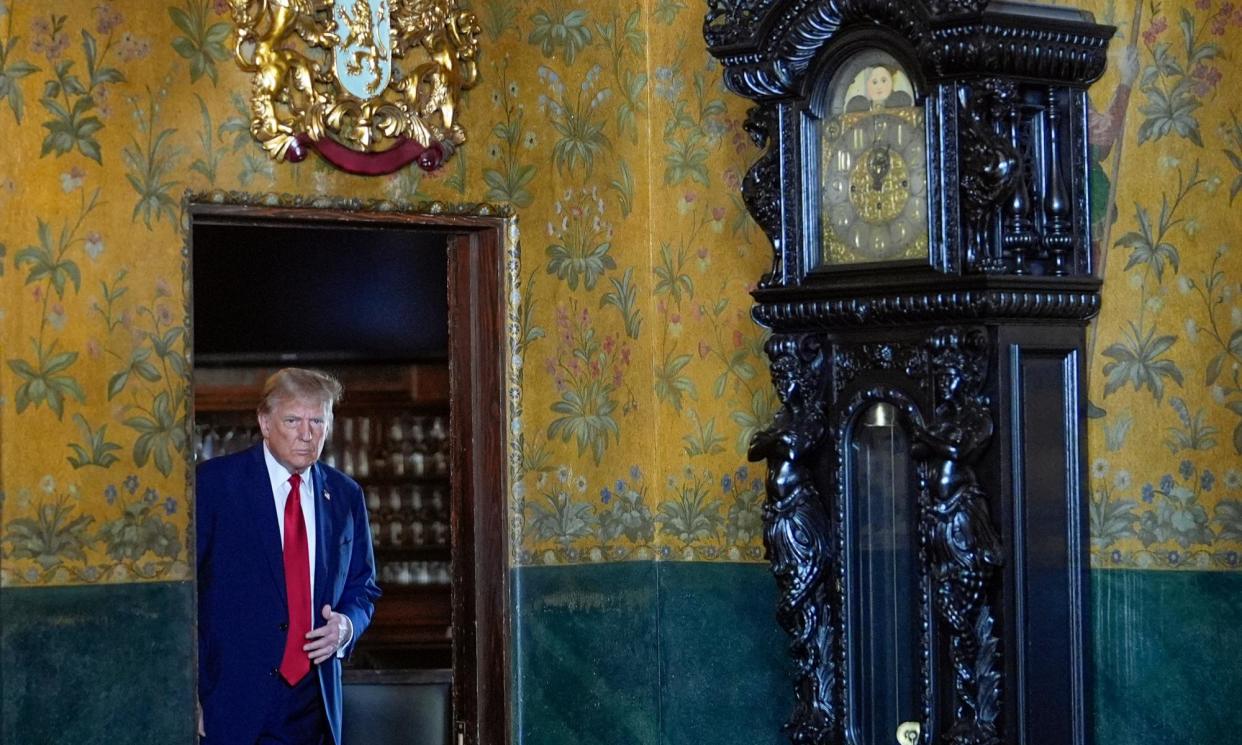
[1088,0,1242,569]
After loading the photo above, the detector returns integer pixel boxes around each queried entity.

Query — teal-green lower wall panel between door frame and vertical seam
[512,561,660,745]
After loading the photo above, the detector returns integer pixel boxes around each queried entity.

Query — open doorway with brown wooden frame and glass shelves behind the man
[186,196,509,744]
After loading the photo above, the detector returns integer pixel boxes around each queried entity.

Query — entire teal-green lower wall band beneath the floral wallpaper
[0,562,1242,745]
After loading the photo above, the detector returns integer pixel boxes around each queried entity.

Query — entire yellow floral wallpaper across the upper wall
[0,0,1242,586]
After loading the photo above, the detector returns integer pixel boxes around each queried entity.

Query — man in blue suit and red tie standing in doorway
[196,369,380,745]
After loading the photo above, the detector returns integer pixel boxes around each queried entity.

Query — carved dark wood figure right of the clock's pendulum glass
[913,328,1002,745]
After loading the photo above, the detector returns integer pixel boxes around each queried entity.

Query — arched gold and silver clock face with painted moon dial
[820,52,928,266]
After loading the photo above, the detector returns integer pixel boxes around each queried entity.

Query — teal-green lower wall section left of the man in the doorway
[0,582,194,745]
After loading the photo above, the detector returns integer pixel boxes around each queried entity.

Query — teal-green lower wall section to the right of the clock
[1092,570,1242,745]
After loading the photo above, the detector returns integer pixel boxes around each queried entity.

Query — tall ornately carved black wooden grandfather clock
[704,0,1114,745]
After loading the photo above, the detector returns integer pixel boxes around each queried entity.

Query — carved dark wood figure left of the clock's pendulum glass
[749,335,837,745]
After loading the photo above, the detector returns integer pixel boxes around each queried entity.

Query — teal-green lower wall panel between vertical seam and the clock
[657,561,794,745]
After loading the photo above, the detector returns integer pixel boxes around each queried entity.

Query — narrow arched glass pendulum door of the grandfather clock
[846,402,922,745]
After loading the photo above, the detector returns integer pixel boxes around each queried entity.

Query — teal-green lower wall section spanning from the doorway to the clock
[513,562,787,745]
